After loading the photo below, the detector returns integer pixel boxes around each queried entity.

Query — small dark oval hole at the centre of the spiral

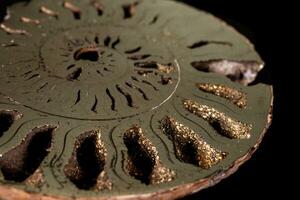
[74,47,100,62]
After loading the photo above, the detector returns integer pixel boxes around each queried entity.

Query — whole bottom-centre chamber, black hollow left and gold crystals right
[124,125,175,184]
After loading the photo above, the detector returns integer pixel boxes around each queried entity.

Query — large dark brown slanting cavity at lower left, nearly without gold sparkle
[0,125,56,182]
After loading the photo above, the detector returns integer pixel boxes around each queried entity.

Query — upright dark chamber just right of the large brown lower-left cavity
[65,132,105,190]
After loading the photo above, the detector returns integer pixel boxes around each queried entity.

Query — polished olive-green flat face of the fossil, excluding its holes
[0,0,272,196]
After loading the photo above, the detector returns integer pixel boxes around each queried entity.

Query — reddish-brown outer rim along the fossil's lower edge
[0,86,274,200]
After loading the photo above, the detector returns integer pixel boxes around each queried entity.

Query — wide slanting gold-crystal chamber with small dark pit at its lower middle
[161,116,227,169]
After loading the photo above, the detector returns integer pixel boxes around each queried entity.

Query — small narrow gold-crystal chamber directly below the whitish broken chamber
[196,83,247,108]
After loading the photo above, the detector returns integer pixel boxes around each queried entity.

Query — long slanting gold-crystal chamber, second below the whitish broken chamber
[183,100,252,139]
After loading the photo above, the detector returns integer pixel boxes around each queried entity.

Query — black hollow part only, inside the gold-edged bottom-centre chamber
[124,135,155,184]
